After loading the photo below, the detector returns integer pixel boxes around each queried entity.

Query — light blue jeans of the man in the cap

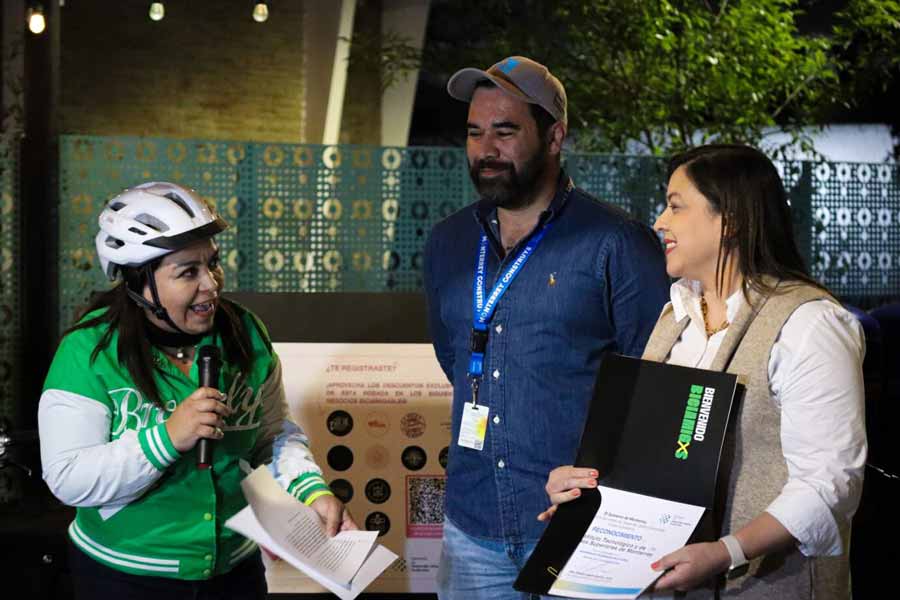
[437,518,580,600]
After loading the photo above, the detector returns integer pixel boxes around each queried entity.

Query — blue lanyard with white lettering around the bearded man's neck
[469,222,553,380]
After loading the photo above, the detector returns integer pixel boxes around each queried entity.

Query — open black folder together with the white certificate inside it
[514,354,738,599]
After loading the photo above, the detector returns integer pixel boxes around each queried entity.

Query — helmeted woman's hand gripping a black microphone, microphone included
[166,346,232,462]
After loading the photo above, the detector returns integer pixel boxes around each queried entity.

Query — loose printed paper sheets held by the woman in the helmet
[225,467,397,600]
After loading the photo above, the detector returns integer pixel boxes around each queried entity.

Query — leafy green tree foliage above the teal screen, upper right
[426,0,900,155]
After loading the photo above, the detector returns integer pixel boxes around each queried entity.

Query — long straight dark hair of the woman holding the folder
[668,144,827,297]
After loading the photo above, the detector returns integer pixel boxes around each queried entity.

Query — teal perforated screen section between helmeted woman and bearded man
[60,136,474,327]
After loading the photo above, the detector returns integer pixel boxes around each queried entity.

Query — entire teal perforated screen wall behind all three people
[59,136,900,327]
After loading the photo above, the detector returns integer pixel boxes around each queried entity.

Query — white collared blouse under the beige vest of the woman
[666,279,866,556]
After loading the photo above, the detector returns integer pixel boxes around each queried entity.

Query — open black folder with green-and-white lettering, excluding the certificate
[513,354,738,594]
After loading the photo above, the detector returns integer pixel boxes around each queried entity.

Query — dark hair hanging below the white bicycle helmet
[63,258,253,406]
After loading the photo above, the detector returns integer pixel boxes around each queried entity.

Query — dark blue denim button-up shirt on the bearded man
[425,174,669,543]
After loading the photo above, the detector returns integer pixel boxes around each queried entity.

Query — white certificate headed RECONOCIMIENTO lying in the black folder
[549,486,704,600]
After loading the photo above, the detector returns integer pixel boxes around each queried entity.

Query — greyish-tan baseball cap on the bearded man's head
[447,56,568,124]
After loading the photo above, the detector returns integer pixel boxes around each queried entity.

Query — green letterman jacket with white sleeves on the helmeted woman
[38,303,331,580]
